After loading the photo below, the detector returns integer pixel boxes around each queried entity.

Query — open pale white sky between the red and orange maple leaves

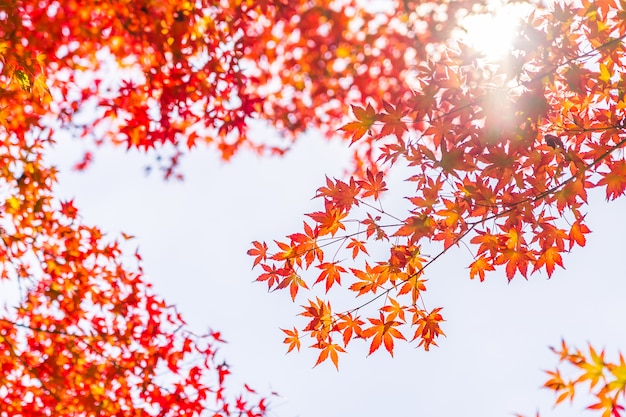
[51,124,626,417]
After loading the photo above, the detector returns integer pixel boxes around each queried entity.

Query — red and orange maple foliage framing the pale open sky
[0,0,626,416]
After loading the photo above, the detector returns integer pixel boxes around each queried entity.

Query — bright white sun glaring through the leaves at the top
[459,0,532,59]
